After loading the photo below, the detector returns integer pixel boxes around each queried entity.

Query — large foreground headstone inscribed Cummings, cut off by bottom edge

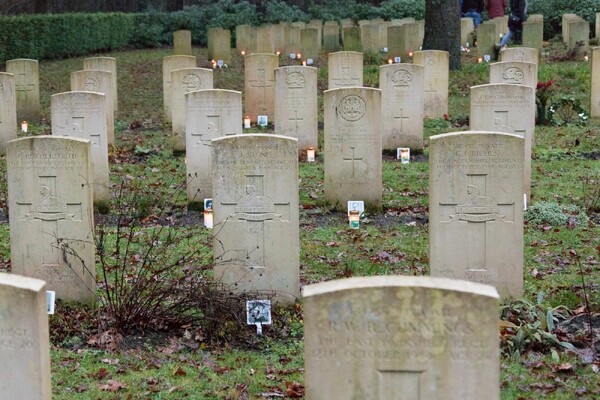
[304,276,500,400]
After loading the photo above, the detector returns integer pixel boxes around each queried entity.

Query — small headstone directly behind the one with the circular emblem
[327,51,363,89]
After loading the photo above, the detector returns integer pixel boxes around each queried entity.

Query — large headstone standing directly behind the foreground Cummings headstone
[429,131,524,298]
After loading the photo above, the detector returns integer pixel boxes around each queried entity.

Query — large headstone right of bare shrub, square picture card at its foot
[212,134,300,303]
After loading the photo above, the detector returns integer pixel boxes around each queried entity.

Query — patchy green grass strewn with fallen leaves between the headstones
[0,43,600,400]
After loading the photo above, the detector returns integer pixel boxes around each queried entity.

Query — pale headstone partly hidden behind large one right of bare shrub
[185,89,242,209]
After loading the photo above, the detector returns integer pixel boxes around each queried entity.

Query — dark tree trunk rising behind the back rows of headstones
[423,0,460,71]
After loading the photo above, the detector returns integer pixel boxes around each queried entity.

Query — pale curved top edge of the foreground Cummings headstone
[303,276,499,299]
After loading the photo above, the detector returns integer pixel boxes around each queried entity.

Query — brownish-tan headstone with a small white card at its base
[244,53,279,122]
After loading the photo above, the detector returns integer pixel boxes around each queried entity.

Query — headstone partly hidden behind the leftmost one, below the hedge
[6,58,41,123]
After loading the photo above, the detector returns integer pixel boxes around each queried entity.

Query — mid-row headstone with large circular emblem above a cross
[324,87,382,210]
